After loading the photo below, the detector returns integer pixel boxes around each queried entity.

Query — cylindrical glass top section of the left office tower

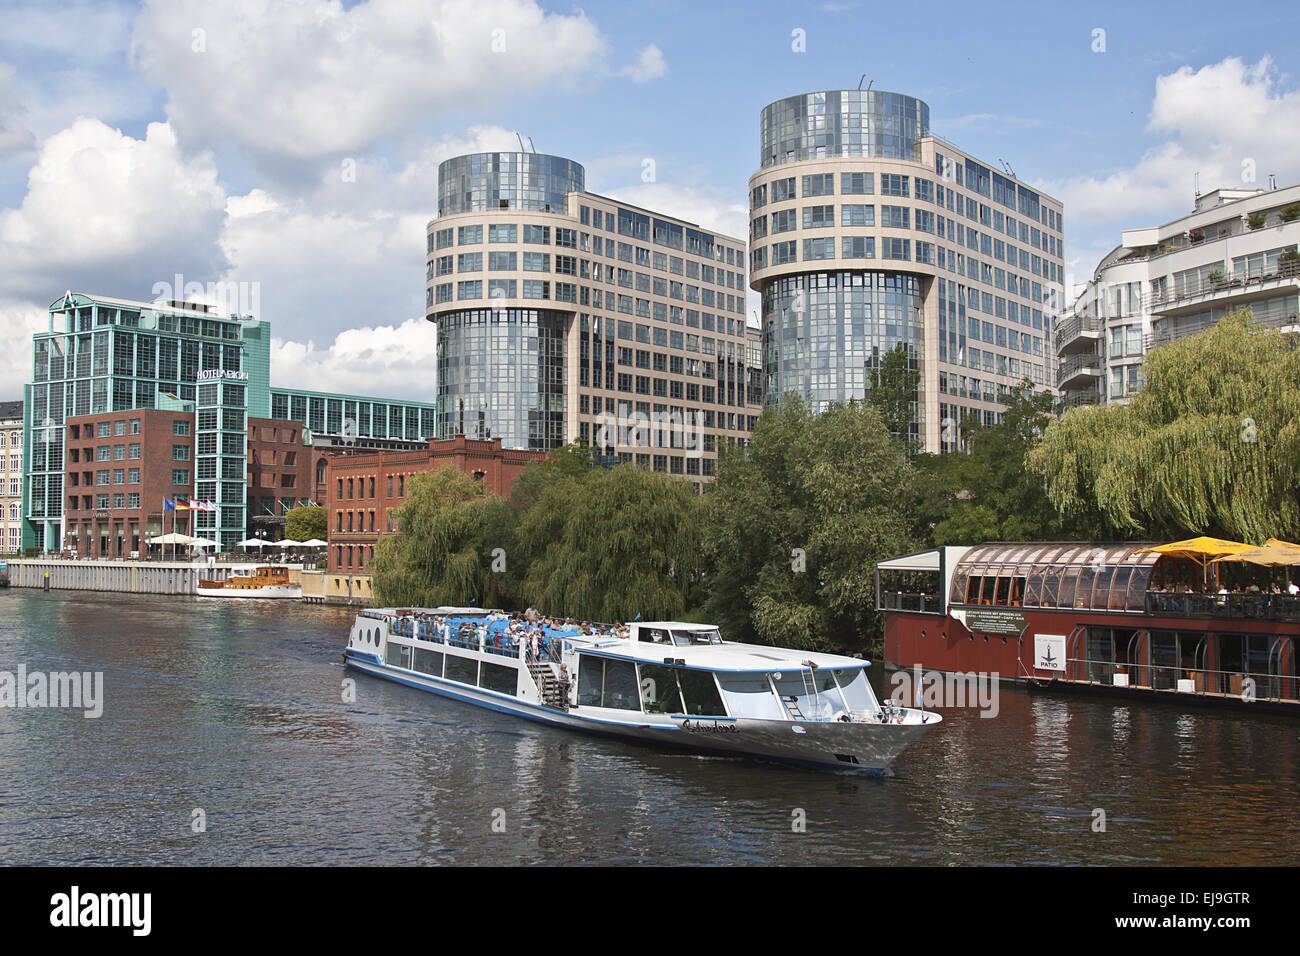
[438,152,586,216]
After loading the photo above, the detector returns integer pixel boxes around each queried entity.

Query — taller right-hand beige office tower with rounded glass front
[749,90,1065,451]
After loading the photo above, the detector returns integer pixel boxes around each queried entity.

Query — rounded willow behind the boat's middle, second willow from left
[516,464,702,623]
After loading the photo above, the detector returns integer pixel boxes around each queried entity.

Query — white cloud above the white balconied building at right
[1041,57,1300,270]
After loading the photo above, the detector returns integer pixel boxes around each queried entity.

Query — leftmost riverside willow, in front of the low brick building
[372,466,501,607]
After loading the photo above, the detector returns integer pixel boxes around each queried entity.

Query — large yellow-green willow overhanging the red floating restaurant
[1030,311,1300,542]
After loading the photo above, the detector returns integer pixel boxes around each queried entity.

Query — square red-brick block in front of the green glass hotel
[64,407,194,558]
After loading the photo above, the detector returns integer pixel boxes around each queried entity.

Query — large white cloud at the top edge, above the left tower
[131,0,607,160]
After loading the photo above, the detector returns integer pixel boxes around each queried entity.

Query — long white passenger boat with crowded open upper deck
[343,607,943,771]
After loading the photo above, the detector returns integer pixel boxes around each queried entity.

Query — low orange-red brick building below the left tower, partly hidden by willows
[330,434,546,572]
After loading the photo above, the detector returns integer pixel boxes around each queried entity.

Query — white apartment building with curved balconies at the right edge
[1057,185,1300,405]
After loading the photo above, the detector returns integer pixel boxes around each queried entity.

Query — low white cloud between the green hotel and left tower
[270,319,438,402]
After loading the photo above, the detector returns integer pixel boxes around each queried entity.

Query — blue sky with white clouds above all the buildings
[0,0,1300,401]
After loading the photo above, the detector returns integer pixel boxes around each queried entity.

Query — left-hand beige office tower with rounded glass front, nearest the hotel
[426,152,758,486]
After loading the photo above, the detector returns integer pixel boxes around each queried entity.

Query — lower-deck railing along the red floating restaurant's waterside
[1065,657,1300,701]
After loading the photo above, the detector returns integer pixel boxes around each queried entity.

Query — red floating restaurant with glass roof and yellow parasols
[876,537,1300,713]
